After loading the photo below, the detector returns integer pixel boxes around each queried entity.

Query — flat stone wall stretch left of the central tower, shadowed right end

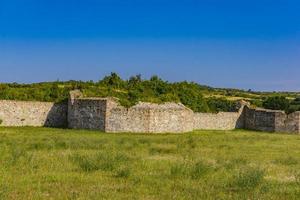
[0,100,67,127]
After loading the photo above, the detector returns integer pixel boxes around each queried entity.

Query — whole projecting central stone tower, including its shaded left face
[68,91,194,133]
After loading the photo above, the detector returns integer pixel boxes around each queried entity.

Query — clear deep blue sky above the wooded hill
[0,0,300,91]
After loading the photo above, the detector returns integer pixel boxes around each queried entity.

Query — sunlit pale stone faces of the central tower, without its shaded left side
[106,103,193,133]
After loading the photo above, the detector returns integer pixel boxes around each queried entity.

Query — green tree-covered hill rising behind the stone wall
[0,73,300,112]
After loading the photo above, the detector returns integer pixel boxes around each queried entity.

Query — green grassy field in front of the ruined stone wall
[0,127,300,200]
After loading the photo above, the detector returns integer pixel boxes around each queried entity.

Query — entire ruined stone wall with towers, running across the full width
[0,91,300,134]
